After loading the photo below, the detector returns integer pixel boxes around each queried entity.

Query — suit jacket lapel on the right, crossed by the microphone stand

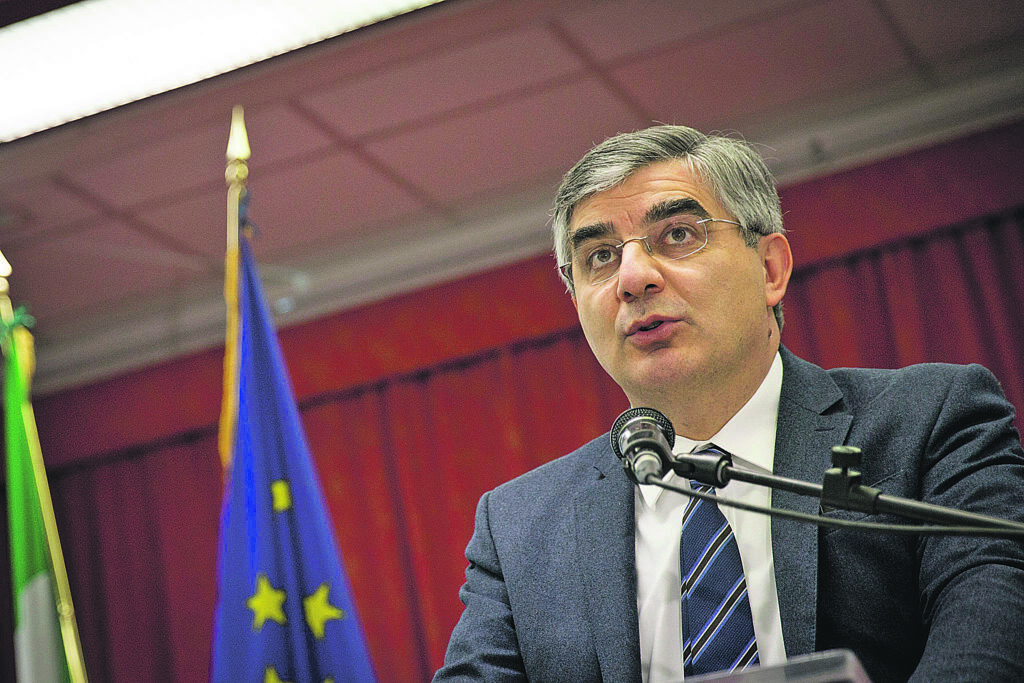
[772,348,853,655]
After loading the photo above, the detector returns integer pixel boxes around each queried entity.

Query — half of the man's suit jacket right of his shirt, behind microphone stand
[772,349,1024,682]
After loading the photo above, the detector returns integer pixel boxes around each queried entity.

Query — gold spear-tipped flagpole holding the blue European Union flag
[218,104,251,470]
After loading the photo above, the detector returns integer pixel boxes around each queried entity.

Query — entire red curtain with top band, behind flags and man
[6,120,1024,681]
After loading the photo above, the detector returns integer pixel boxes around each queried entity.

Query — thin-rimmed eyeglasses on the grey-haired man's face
[558,218,740,285]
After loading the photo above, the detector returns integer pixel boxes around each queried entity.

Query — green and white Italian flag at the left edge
[3,324,70,683]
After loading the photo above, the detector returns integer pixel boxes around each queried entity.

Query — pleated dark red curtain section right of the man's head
[782,210,1024,413]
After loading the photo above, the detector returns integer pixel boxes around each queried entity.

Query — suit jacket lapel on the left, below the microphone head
[573,445,641,681]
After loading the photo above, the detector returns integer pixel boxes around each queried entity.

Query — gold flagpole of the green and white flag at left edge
[0,248,89,683]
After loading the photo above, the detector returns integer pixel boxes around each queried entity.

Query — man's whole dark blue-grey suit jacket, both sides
[435,349,1024,683]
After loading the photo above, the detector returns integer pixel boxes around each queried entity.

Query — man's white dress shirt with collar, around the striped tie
[634,353,785,683]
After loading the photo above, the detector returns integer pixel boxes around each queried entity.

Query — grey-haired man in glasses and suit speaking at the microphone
[436,126,1024,683]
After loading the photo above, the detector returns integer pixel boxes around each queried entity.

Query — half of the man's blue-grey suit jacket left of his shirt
[436,435,640,681]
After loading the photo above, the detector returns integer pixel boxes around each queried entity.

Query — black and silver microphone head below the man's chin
[608,408,676,483]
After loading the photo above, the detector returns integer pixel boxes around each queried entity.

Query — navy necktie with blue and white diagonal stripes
[679,448,759,676]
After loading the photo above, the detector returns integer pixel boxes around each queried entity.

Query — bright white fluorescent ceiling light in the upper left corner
[0,0,440,142]
